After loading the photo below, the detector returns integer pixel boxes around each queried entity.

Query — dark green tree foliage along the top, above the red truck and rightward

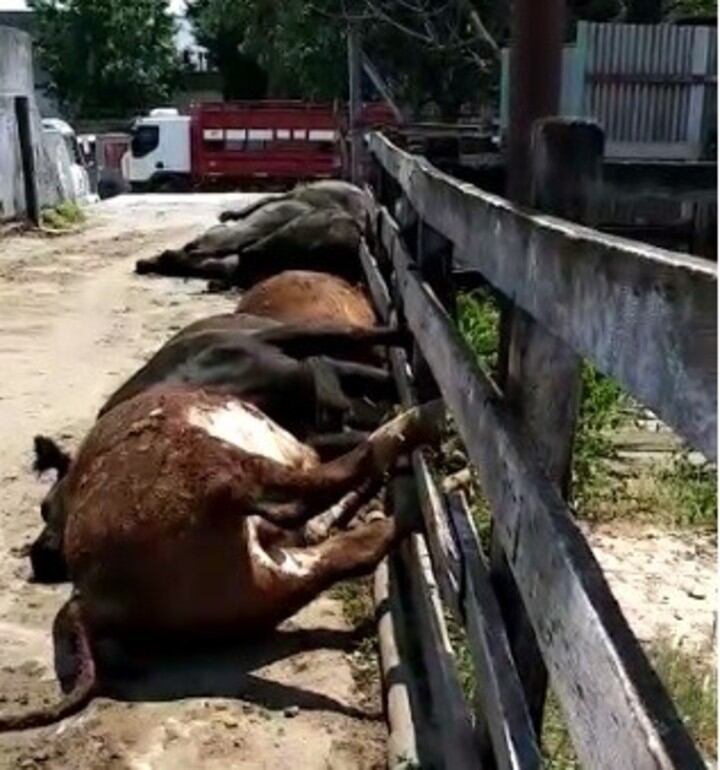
[188,0,716,118]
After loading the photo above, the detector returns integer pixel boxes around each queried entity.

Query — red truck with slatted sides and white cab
[123,100,398,190]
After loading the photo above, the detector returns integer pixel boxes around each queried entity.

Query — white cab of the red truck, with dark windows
[122,108,191,189]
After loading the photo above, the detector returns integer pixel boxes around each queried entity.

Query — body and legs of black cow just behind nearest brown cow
[100,314,396,426]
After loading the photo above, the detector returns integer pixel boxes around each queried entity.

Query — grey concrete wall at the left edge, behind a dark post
[0,27,64,220]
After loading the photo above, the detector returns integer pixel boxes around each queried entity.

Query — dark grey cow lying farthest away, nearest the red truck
[136,181,370,286]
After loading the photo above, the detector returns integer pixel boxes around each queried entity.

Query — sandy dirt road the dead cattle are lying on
[0,195,385,770]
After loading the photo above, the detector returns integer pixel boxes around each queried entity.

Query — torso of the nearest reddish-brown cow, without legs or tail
[65,391,318,636]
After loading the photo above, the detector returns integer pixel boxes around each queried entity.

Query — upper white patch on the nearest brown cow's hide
[187,401,318,468]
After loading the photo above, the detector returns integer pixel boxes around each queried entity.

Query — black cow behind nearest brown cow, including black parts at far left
[29,314,404,583]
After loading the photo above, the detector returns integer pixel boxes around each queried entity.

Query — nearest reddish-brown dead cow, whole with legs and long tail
[0,388,442,731]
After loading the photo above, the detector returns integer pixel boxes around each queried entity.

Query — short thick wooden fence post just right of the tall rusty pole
[491,118,604,737]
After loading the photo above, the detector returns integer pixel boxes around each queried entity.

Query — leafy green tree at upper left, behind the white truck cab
[29,0,178,117]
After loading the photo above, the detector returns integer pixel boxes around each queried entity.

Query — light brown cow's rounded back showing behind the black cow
[237,270,376,329]
